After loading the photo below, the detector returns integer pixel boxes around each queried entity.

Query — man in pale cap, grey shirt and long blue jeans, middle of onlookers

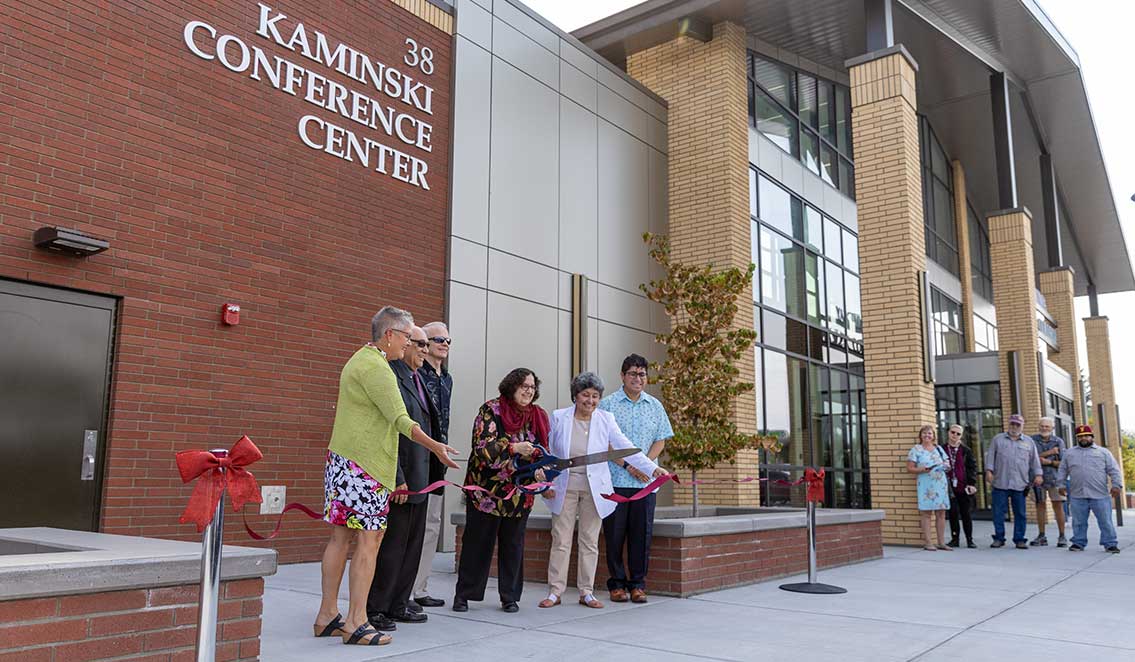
[985,413,1044,550]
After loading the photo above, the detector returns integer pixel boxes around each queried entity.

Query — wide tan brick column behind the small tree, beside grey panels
[627,23,760,505]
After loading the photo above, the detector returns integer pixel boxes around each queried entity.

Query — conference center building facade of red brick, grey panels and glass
[0,0,1135,562]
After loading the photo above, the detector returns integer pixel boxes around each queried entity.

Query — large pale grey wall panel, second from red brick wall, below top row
[488,57,560,267]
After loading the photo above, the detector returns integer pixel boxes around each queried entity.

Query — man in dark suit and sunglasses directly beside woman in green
[367,326,440,631]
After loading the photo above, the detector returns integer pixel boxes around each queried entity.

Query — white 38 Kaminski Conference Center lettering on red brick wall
[183,3,434,191]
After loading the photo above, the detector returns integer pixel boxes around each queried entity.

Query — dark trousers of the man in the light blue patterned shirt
[603,487,656,590]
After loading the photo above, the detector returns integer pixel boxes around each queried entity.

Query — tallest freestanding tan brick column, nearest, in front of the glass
[847,47,936,544]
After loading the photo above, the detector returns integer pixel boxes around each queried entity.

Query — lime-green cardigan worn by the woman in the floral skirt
[328,345,418,489]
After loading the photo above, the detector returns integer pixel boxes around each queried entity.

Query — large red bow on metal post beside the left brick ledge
[177,436,264,534]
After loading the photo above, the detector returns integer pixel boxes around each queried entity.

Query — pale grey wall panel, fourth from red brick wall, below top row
[598,118,650,291]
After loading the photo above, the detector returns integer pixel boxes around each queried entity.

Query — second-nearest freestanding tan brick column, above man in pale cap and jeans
[989,208,1044,430]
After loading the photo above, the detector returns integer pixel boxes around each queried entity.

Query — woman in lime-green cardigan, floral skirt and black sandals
[314,305,457,646]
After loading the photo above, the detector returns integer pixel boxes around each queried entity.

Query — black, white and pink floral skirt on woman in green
[323,451,390,531]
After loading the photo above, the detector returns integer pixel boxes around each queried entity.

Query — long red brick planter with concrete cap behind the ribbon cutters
[453,509,883,597]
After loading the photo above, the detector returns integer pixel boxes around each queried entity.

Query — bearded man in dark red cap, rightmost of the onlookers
[1057,425,1124,554]
